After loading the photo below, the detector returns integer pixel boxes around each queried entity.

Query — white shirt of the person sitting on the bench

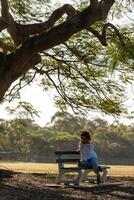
[79,142,97,160]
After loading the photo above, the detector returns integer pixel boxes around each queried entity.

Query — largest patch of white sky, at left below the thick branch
[0,83,58,126]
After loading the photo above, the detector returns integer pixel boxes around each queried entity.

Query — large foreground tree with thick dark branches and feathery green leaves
[0,0,134,114]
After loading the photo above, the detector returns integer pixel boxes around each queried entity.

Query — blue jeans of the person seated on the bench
[81,158,98,173]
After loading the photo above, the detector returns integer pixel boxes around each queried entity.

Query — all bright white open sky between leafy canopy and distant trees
[0,0,134,126]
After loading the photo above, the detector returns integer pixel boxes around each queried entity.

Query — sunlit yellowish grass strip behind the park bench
[0,162,134,177]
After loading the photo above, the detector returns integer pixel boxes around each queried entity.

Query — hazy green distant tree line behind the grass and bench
[0,112,134,164]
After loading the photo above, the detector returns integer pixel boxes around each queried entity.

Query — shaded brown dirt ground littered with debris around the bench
[0,170,134,200]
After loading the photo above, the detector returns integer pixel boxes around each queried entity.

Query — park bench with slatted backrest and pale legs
[55,151,110,185]
